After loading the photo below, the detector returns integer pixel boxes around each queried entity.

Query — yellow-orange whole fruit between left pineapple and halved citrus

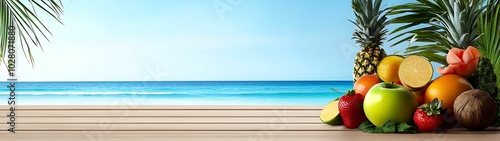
[377,55,403,83]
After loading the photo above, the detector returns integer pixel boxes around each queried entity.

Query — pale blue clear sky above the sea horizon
[4,0,418,81]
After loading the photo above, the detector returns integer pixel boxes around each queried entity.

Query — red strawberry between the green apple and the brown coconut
[413,98,444,132]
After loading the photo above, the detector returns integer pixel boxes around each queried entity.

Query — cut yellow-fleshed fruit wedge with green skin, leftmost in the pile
[319,100,342,125]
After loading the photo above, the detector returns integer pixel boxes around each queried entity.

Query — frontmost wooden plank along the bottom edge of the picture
[0,131,500,141]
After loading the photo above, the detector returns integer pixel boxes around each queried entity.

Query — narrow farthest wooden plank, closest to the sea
[0,105,323,111]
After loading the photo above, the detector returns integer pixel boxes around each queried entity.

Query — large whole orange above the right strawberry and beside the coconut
[425,74,473,110]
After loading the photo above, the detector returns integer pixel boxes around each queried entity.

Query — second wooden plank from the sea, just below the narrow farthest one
[0,109,321,117]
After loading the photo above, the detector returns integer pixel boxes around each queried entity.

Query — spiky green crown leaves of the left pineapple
[349,0,390,48]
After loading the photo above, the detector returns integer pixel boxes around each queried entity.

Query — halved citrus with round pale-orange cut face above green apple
[398,55,434,91]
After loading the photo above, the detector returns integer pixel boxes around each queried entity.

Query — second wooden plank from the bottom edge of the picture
[0,121,345,132]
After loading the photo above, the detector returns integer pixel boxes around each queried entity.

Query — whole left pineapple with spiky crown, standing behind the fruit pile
[349,0,389,82]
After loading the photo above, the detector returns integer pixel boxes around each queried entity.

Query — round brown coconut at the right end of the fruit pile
[453,89,498,130]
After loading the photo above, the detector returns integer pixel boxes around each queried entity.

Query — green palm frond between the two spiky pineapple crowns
[389,0,449,65]
